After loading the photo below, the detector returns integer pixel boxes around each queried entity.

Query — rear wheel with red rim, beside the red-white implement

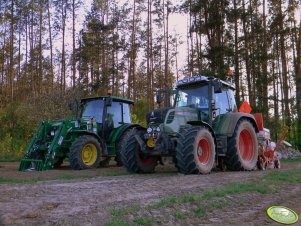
[226,119,258,171]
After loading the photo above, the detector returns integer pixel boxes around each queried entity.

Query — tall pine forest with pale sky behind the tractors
[0,0,301,161]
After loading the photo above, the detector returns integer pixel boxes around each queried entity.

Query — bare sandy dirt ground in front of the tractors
[0,162,301,226]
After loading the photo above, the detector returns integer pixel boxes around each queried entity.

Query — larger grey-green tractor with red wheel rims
[121,76,258,174]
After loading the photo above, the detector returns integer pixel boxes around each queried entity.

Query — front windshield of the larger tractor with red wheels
[175,85,208,109]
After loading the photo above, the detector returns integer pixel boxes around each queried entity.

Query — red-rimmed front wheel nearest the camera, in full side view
[176,127,215,174]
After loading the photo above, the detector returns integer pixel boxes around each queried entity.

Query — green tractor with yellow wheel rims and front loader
[19,95,138,171]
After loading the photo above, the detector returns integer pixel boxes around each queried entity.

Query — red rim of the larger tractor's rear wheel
[239,129,255,162]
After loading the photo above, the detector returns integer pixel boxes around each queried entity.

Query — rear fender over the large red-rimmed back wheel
[212,112,259,137]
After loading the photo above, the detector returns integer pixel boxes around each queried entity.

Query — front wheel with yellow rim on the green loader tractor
[69,135,101,170]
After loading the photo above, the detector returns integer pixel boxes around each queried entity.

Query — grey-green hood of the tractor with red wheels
[164,107,199,133]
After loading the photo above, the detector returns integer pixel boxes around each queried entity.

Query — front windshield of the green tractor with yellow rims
[82,100,103,123]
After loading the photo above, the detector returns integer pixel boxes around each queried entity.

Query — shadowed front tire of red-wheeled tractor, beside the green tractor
[120,130,158,173]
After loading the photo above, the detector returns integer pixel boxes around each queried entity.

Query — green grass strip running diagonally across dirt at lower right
[103,169,301,225]
